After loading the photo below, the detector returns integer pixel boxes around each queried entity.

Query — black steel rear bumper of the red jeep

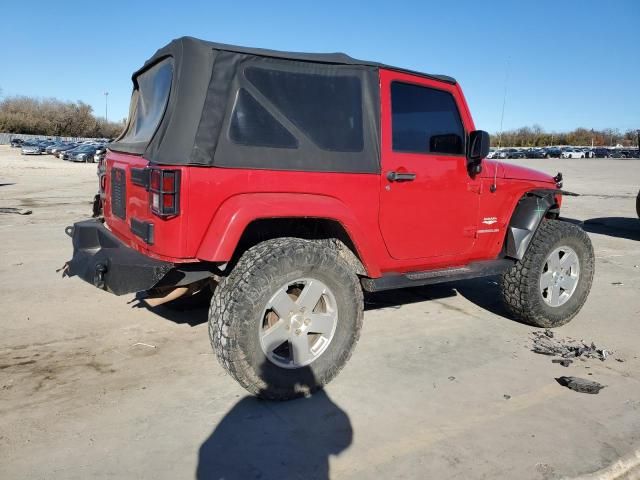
[66,220,174,295]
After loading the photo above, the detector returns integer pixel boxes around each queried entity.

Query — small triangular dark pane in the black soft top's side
[229,88,298,148]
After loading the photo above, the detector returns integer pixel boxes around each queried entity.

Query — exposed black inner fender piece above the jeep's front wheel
[504,188,577,260]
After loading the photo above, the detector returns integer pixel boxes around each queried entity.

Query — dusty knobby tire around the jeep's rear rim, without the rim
[209,238,363,400]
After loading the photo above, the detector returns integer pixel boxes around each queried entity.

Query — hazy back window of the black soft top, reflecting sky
[121,58,173,143]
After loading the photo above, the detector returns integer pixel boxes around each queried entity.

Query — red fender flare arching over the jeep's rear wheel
[196,193,379,275]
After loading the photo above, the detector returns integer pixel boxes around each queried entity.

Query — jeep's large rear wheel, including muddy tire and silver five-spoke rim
[209,238,363,400]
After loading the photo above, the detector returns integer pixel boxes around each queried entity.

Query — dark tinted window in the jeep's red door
[391,82,464,155]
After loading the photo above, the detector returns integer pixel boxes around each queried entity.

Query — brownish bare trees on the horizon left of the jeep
[0,96,125,138]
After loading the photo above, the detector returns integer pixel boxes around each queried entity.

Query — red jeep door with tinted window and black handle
[379,70,480,259]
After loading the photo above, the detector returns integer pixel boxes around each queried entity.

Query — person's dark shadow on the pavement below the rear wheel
[196,367,353,480]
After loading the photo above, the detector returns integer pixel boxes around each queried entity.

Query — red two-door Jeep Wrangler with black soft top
[67,38,594,399]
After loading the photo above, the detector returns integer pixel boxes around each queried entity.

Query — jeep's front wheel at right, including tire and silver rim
[501,220,595,328]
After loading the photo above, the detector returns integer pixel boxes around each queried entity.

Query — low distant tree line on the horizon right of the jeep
[491,125,638,147]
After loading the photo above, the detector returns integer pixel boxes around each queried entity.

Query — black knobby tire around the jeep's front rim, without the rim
[500,219,595,328]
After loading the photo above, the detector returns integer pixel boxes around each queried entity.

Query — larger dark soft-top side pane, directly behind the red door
[245,67,364,152]
